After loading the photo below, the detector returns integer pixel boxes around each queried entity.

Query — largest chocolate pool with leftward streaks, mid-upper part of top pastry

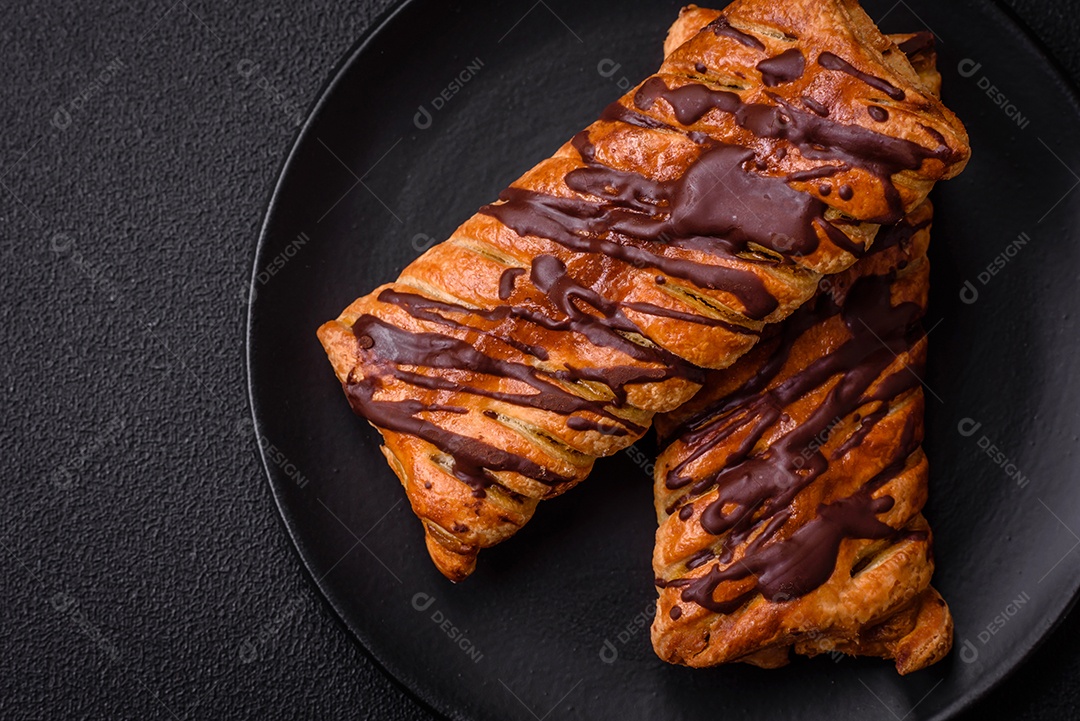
[481,144,827,319]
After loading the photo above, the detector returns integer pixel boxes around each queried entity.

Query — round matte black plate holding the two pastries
[248,0,1080,721]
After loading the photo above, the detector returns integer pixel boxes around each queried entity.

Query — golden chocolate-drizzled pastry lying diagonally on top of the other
[319,0,970,581]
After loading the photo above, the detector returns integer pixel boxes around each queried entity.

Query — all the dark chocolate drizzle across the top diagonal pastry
[346,23,951,507]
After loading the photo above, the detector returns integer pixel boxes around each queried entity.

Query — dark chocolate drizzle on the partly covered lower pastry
[665,241,922,613]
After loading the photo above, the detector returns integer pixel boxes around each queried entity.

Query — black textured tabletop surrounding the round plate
[6,0,1080,719]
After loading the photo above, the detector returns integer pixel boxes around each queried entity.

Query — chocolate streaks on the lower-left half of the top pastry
[346,269,702,494]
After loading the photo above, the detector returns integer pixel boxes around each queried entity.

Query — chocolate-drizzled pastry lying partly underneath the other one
[652,8,953,674]
